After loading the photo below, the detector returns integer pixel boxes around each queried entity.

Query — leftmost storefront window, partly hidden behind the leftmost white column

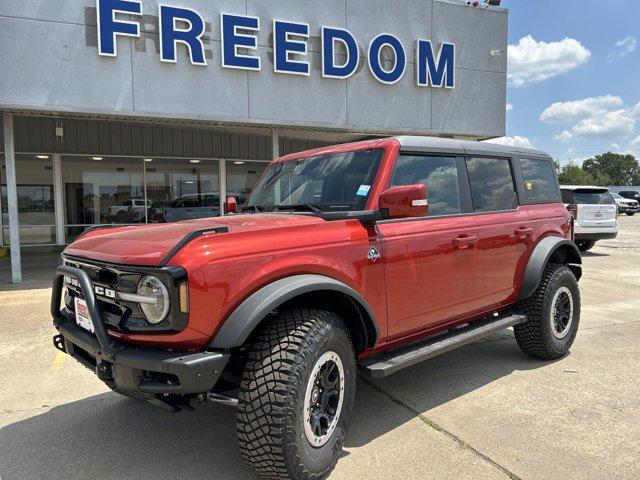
[0,154,56,245]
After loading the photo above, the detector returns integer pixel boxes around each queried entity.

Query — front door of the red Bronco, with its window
[378,154,481,338]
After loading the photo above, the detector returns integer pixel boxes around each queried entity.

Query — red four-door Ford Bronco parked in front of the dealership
[51,137,581,479]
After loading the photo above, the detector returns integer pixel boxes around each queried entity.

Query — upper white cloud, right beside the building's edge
[508,35,591,87]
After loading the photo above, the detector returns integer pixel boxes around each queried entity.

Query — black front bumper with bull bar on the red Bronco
[51,267,229,400]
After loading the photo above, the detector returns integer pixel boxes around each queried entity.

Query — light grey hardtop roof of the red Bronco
[394,135,551,158]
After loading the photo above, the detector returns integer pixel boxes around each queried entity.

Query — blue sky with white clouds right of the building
[494,0,640,165]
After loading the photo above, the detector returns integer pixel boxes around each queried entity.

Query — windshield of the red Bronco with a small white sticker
[244,149,384,212]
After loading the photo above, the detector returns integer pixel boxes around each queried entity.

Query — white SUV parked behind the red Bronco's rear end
[560,185,618,252]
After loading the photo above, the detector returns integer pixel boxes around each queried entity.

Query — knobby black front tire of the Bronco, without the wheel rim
[237,308,356,480]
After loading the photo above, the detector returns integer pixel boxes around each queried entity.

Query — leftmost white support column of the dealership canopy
[3,113,22,283]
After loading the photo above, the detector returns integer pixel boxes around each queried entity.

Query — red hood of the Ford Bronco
[64,213,325,266]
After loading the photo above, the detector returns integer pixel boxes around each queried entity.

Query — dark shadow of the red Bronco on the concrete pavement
[0,332,547,480]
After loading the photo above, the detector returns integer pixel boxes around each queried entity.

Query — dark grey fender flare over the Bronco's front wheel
[209,274,379,350]
